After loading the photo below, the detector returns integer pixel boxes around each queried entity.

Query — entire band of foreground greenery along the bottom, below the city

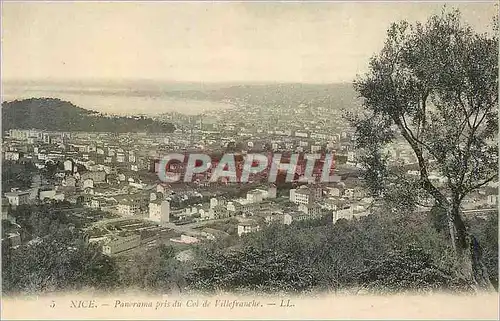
[2,201,498,294]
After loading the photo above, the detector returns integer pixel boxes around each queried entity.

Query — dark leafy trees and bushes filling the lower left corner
[2,203,121,294]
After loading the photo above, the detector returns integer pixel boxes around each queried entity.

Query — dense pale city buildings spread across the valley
[2,95,498,255]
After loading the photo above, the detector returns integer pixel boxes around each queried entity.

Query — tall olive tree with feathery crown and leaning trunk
[349,10,498,288]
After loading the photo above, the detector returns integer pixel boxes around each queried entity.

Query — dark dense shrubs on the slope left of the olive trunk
[183,213,484,291]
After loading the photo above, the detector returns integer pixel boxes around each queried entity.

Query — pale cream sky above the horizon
[2,2,495,83]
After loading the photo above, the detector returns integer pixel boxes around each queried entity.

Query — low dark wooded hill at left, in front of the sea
[2,98,175,133]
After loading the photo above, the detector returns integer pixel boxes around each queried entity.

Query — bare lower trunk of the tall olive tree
[448,202,494,291]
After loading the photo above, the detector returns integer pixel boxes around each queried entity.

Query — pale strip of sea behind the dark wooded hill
[1,80,233,116]
